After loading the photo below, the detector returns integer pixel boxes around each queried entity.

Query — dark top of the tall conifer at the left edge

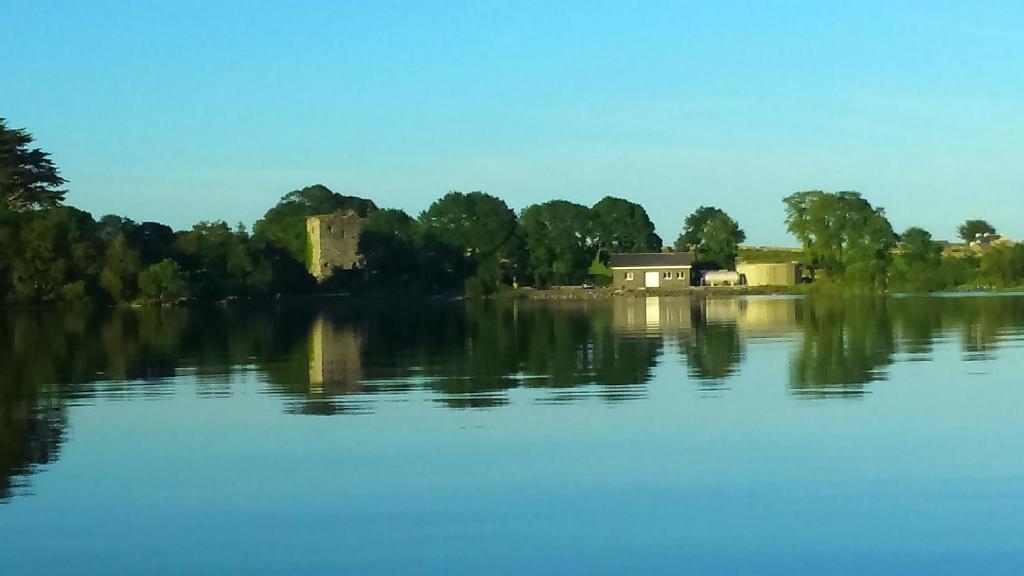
[0,118,68,210]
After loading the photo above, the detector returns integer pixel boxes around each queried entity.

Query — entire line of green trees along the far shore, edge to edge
[0,119,1024,303]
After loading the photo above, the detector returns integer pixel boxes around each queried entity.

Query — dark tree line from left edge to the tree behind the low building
[0,119,743,303]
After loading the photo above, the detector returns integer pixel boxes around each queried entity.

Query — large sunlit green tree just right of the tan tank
[784,191,896,288]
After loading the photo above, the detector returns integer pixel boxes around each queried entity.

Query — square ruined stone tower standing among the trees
[306,210,362,280]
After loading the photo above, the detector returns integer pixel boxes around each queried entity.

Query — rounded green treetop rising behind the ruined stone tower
[253,184,377,264]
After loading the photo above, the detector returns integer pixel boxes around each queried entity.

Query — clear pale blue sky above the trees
[8,0,1024,245]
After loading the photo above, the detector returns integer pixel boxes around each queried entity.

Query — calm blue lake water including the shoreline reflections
[0,296,1024,575]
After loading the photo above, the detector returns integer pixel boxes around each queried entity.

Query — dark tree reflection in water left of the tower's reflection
[0,307,319,499]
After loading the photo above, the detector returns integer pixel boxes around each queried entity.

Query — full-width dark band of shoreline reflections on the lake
[6,296,1024,500]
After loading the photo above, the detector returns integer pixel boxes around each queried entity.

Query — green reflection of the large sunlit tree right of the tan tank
[790,298,895,395]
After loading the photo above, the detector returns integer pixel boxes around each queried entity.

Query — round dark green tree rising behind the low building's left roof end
[590,196,662,252]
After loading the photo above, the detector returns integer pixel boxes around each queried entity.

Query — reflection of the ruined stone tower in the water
[309,317,362,394]
